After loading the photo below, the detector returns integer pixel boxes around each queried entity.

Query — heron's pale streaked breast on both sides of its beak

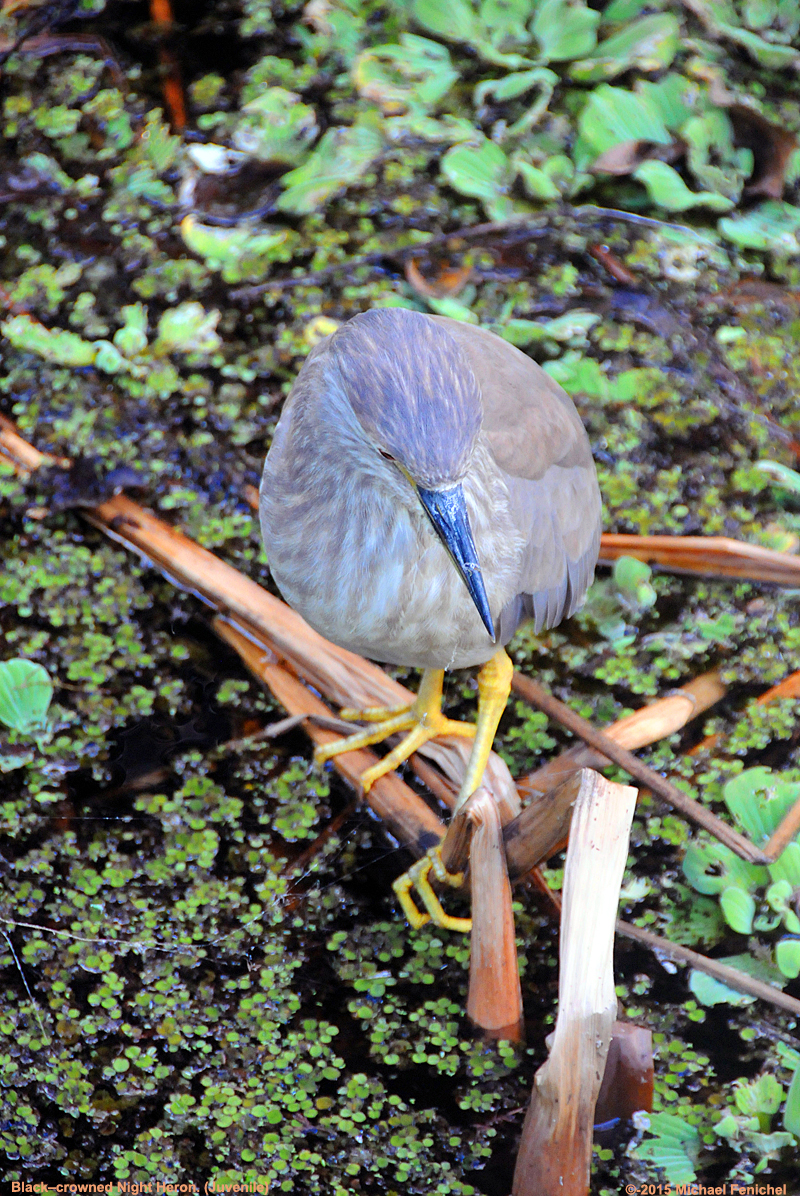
[261,428,524,669]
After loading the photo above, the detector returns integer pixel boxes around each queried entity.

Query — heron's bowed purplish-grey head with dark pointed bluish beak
[330,307,495,640]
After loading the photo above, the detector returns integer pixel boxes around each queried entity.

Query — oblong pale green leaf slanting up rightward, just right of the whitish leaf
[275,122,383,215]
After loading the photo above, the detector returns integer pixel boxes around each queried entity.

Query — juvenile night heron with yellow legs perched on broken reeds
[261,307,600,926]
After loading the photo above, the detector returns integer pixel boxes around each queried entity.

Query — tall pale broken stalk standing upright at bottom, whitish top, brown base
[513,773,636,1196]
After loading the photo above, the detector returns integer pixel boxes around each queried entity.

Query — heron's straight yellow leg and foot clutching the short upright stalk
[392,648,514,932]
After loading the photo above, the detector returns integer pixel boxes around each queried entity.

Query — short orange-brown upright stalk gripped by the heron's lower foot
[466,788,523,1042]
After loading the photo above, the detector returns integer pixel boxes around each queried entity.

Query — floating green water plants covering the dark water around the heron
[0,0,800,1196]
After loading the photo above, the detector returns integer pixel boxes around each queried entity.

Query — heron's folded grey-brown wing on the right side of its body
[430,316,600,642]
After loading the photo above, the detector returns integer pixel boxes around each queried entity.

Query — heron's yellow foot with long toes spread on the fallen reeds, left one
[314,669,475,793]
